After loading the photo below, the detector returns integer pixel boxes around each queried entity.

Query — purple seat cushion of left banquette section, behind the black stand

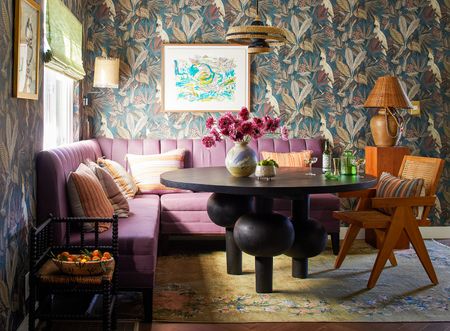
[71,194,160,256]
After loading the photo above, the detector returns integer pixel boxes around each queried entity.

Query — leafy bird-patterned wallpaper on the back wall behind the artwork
[84,0,450,224]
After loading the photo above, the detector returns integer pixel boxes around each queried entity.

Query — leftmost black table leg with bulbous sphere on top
[207,193,253,275]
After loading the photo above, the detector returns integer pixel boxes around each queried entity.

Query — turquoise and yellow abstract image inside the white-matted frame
[174,55,236,102]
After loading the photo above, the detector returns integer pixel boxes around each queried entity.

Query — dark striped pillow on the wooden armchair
[376,172,424,216]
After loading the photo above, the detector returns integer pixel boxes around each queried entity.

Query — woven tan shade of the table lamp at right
[364,76,413,109]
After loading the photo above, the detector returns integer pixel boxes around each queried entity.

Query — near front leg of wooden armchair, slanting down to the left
[367,217,404,289]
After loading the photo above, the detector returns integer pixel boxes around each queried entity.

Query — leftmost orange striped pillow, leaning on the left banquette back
[67,163,114,232]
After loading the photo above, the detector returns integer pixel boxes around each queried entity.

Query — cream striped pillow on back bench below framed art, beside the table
[126,148,186,194]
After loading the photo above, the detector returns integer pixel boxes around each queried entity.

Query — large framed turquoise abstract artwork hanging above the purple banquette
[161,44,250,112]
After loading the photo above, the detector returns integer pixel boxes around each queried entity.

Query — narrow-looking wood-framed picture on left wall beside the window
[13,0,40,100]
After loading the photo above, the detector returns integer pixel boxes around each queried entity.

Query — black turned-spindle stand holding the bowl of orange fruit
[29,215,119,331]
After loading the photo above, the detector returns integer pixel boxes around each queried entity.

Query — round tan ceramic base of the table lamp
[370,110,398,147]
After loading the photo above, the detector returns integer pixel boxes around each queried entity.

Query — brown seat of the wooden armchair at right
[333,210,391,229]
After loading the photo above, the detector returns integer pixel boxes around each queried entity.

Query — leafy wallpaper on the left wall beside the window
[0,0,84,331]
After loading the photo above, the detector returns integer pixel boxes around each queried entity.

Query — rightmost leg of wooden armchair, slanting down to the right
[405,218,439,285]
